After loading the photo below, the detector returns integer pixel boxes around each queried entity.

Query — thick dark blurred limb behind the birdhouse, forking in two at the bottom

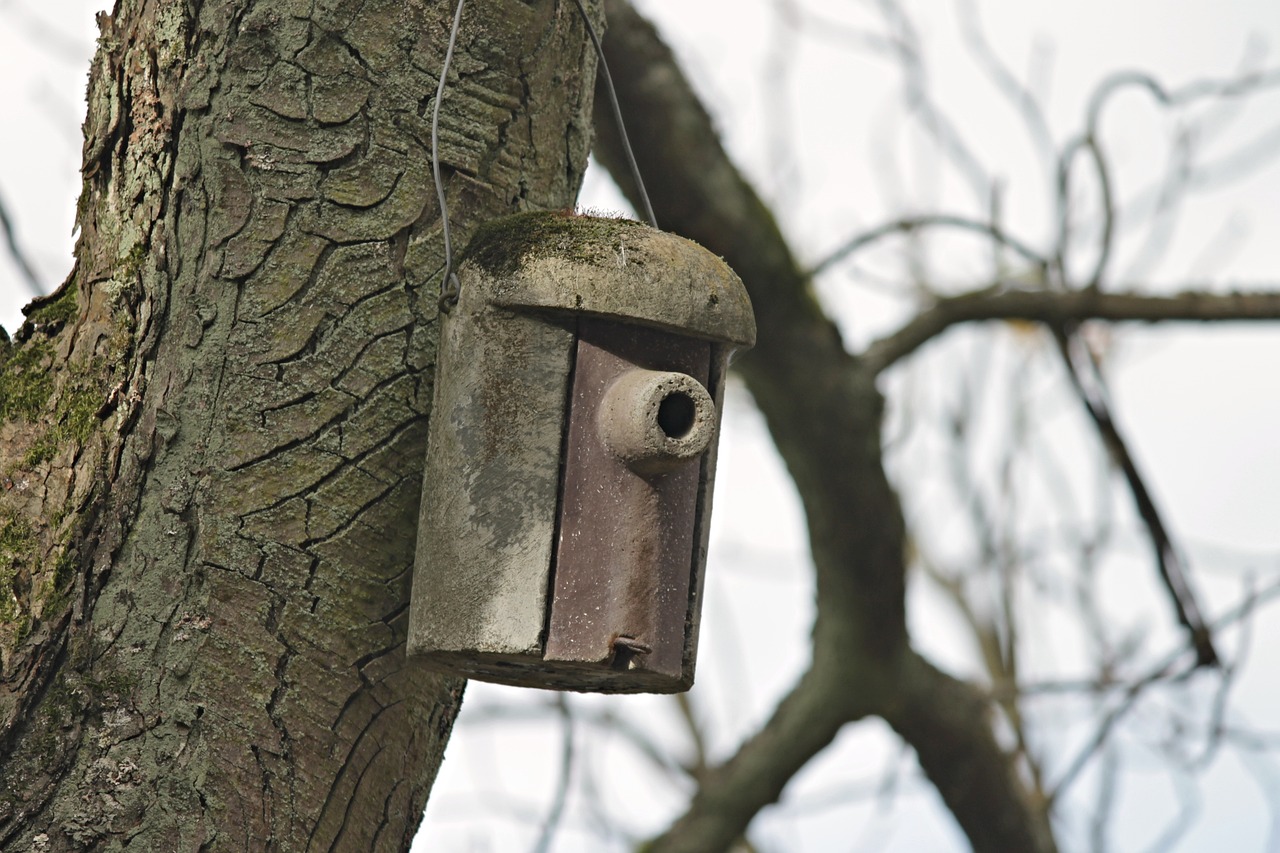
[596,0,1055,852]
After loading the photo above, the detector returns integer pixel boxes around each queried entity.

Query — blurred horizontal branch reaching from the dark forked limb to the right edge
[863,284,1280,373]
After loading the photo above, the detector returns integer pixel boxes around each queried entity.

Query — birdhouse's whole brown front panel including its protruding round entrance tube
[545,319,718,681]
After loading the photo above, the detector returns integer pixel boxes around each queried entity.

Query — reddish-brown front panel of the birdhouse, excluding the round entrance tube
[544,319,718,686]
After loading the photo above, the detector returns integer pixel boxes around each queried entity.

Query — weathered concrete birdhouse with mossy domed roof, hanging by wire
[408,213,755,693]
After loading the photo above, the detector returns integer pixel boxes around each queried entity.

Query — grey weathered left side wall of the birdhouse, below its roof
[408,302,573,656]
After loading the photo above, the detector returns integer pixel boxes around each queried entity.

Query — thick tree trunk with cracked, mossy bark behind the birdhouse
[0,0,595,850]
